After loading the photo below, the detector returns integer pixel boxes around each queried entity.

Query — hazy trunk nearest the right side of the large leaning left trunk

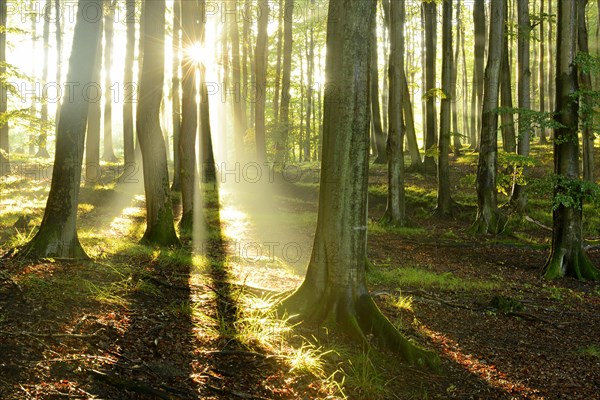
[85,18,104,186]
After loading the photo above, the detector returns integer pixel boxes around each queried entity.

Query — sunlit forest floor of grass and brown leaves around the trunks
[0,147,600,399]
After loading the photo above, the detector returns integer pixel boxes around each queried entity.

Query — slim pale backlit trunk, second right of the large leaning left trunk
[102,1,117,162]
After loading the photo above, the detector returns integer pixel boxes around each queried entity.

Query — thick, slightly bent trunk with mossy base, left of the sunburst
[136,0,179,246]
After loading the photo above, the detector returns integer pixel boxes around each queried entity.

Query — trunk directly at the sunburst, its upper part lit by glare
[177,0,200,233]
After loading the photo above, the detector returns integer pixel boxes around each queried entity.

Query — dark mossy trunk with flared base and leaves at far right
[544,1,600,280]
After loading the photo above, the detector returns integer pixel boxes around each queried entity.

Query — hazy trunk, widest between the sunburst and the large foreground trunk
[254,1,269,162]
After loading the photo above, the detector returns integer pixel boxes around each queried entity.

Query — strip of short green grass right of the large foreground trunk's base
[367,267,500,291]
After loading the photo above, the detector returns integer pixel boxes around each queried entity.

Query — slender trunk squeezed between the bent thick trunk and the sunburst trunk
[171,0,181,192]
